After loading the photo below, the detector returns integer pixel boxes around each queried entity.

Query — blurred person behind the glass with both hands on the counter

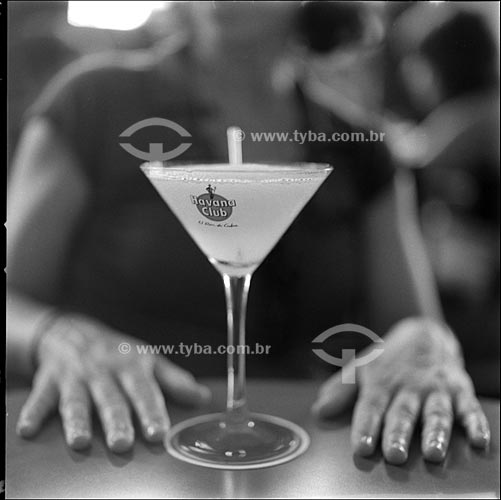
[8,2,490,464]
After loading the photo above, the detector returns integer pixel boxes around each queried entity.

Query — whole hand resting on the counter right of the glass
[313,318,490,464]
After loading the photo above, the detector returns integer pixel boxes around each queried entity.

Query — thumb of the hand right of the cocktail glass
[311,363,357,418]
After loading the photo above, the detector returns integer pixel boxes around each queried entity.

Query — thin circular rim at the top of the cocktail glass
[139,161,334,174]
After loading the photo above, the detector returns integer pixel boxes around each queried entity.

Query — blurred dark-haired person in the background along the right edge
[384,5,500,396]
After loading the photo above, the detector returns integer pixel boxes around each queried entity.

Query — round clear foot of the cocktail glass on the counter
[166,413,310,470]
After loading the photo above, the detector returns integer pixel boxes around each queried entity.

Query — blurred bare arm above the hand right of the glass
[365,175,443,332]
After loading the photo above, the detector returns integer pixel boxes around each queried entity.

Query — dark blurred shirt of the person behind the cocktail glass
[31,45,393,375]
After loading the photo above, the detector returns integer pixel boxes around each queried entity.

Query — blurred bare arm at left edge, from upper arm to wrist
[7,118,90,375]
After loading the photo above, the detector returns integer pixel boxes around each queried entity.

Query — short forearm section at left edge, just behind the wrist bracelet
[7,287,57,378]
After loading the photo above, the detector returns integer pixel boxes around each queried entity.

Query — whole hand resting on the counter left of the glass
[17,316,210,453]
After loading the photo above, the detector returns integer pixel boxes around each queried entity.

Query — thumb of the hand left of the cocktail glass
[155,358,211,406]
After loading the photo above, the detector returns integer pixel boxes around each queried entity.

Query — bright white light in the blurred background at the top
[68,1,169,31]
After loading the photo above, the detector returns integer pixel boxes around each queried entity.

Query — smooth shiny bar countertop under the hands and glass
[6,380,499,498]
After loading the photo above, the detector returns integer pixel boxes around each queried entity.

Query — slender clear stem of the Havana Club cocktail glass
[223,274,251,425]
